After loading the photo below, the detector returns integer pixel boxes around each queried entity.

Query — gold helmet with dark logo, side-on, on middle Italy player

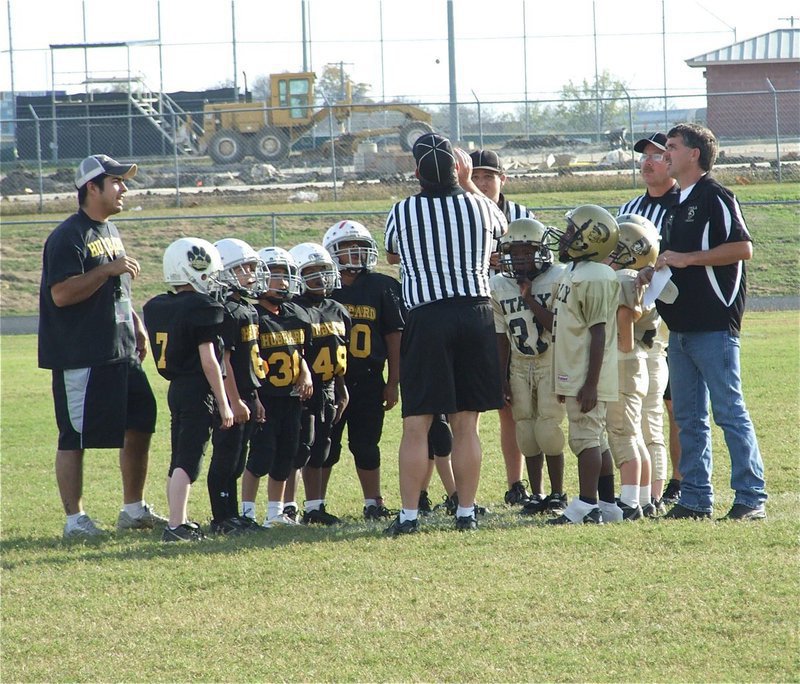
[547,204,619,263]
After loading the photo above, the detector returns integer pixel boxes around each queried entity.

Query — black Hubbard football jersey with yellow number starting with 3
[255,302,311,397]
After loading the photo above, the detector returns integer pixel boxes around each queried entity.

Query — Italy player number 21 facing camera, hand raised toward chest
[489,218,567,514]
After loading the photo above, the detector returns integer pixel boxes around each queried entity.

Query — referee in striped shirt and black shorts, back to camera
[385,133,508,536]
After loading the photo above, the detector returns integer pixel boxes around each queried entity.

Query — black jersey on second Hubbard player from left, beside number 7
[222,297,266,395]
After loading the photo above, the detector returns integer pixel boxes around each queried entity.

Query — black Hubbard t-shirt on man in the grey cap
[39,210,136,369]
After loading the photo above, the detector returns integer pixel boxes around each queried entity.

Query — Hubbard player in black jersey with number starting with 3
[242,247,313,527]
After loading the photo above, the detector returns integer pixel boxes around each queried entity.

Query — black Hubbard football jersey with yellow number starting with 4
[295,296,350,393]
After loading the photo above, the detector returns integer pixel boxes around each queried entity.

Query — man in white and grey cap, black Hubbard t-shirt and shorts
[39,154,166,538]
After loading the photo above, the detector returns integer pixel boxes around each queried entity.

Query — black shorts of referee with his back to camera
[400,297,503,418]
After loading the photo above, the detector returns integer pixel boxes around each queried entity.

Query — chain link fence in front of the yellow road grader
[0,89,800,207]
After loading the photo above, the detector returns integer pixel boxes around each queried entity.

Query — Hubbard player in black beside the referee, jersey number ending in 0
[322,221,403,520]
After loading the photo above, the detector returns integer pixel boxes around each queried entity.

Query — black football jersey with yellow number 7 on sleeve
[143,291,225,380]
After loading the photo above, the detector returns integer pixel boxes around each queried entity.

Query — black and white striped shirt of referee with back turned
[385,186,508,309]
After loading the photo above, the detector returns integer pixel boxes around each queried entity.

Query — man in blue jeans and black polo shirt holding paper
[642,124,767,520]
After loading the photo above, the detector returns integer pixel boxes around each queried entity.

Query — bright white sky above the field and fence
[0,0,800,106]
